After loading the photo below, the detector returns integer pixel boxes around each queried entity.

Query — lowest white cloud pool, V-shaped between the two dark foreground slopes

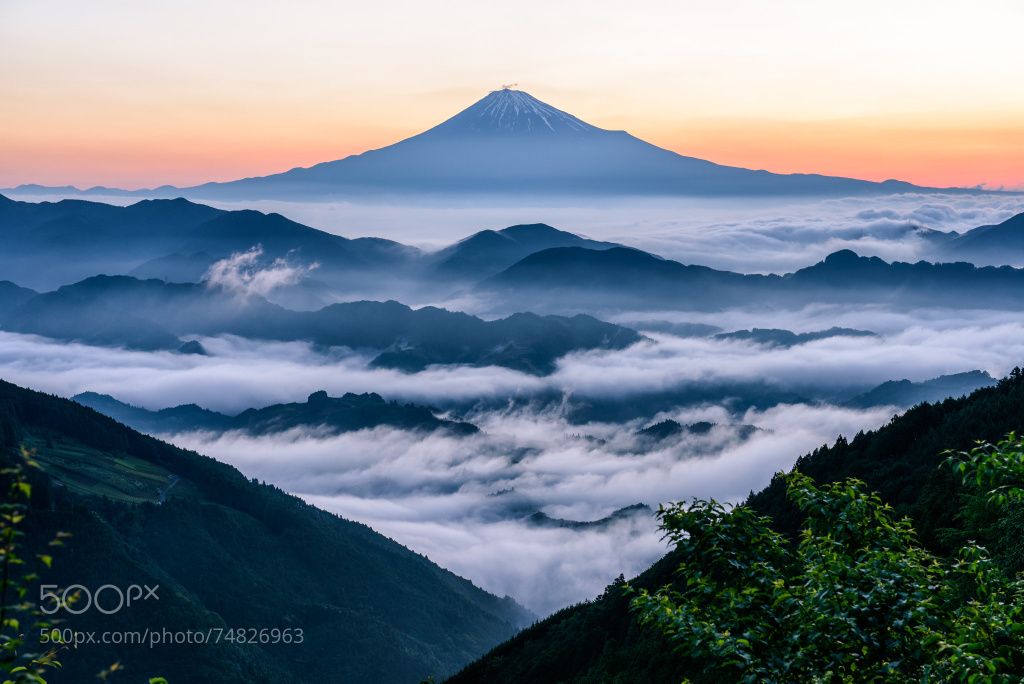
[168,405,891,614]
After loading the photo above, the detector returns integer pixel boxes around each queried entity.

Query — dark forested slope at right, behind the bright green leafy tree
[446,369,1024,684]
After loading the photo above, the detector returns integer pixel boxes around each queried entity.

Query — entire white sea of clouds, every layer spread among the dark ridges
[0,195,1024,614]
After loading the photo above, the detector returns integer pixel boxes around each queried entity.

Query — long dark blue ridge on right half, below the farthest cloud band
[476,247,1024,311]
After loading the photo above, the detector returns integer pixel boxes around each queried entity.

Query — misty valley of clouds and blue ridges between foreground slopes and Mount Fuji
[0,185,1024,615]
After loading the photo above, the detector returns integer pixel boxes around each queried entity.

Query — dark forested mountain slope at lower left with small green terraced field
[0,381,532,684]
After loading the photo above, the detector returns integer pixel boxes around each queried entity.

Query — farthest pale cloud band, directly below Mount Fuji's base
[197,189,1024,273]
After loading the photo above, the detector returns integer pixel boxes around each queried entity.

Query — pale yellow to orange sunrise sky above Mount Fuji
[0,0,1024,188]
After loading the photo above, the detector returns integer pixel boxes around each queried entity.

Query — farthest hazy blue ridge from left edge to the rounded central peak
[0,196,623,290]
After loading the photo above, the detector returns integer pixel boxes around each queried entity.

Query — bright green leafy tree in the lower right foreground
[633,435,1024,684]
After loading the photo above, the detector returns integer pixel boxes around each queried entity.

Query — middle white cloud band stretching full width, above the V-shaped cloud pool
[0,307,1024,413]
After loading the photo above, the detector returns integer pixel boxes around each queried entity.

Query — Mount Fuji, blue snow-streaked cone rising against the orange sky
[6,88,969,200]
